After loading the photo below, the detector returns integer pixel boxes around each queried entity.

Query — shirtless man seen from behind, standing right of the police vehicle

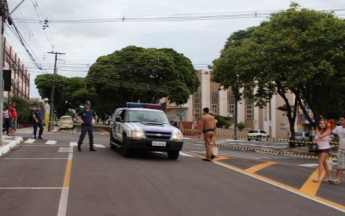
[201,107,215,161]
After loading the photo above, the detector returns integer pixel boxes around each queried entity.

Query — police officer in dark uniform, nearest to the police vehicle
[75,101,98,151]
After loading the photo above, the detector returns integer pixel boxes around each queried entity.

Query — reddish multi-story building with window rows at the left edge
[2,38,30,102]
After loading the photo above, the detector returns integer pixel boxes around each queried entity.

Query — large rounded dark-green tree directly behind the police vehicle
[86,46,200,113]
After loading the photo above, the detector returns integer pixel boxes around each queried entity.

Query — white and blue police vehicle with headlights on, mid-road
[110,108,183,160]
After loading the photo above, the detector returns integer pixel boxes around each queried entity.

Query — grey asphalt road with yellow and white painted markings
[0,134,345,216]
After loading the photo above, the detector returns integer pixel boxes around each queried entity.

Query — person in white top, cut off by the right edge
[331,114,345,185]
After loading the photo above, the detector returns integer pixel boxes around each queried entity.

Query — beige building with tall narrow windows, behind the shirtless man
[161,70,294,138]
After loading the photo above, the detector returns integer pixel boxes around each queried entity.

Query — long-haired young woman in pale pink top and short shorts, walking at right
[313,120,332,183]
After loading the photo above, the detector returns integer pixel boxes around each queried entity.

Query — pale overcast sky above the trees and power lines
[5,0,345,97]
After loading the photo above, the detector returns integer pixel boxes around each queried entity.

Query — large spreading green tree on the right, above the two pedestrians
[213,5,345,147]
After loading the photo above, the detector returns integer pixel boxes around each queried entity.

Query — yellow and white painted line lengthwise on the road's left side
[57,148,73,216]
